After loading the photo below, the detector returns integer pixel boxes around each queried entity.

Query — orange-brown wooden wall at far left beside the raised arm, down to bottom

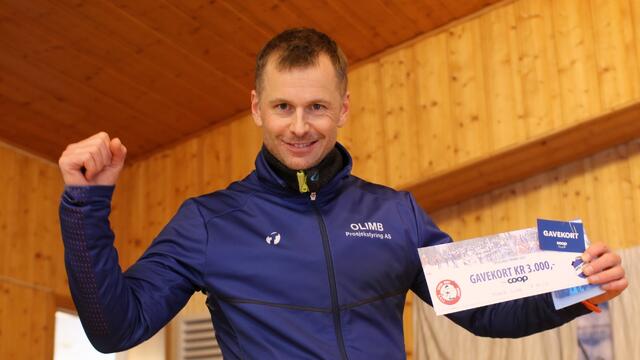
[0,143,64,359]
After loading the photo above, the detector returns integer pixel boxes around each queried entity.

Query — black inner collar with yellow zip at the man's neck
[262,146,344,193]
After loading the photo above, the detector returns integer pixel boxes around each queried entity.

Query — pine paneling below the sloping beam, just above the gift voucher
[432,140,640,248]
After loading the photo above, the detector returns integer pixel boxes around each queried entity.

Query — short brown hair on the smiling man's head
[255,28,348,94]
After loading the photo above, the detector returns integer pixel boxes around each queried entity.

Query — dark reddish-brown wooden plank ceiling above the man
[0,0,499,161]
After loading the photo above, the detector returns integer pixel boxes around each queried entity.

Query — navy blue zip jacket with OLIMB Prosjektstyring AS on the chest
[60,146,587,359]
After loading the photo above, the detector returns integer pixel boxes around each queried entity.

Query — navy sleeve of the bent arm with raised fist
[59,186,207,353]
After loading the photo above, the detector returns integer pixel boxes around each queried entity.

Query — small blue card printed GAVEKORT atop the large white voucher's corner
[538,219,585,253]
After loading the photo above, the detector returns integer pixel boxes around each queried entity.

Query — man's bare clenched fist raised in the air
[58,132,127,186]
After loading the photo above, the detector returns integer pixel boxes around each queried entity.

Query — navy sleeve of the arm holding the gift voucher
[409,196,589,338]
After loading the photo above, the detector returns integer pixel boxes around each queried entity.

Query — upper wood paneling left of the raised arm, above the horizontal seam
[0,143,68,294]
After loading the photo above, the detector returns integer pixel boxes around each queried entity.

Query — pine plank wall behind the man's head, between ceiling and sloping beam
[114,0,640,260]
